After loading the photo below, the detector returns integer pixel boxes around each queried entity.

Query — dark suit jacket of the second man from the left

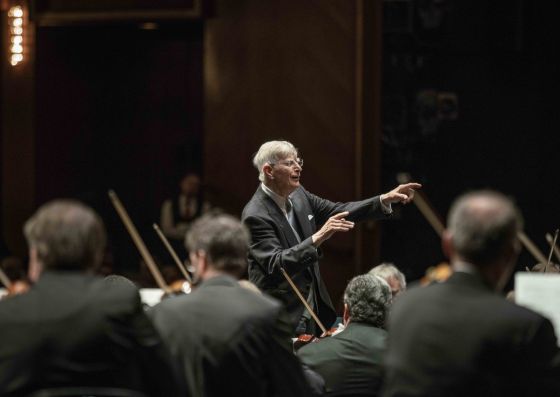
[150,276,310,397]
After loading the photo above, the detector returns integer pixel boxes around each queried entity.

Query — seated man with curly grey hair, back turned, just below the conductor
[298,274,391,396]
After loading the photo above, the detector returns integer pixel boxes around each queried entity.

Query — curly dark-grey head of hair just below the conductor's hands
[344,274,392,328]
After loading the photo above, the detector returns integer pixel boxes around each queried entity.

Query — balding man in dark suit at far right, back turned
[383,190,560,397]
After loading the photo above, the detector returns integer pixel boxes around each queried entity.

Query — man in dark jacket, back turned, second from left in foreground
[149,215,316,397]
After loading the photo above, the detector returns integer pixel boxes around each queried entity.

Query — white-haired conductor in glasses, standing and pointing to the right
[242,141,421,334]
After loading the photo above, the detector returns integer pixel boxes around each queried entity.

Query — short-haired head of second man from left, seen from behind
[185,214,249,276]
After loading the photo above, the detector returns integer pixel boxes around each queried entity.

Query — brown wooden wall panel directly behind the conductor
[204,0,378,310]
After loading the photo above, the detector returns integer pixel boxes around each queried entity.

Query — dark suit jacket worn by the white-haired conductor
[241,186,387,327]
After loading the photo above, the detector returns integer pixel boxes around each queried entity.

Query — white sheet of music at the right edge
[515,272,560,345]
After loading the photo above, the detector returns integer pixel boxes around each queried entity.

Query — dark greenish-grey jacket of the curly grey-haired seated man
[297,322,387,396]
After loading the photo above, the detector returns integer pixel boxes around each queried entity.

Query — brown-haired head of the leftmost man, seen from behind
[24,200,106,270]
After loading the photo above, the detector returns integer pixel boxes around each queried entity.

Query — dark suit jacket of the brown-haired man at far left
[0,271,178,396]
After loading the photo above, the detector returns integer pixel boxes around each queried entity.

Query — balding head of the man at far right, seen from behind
[447,190,523,265]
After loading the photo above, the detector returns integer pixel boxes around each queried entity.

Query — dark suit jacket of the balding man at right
[383,272,560,397]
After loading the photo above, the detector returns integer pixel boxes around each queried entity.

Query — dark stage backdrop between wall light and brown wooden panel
[36,22,203,271]
